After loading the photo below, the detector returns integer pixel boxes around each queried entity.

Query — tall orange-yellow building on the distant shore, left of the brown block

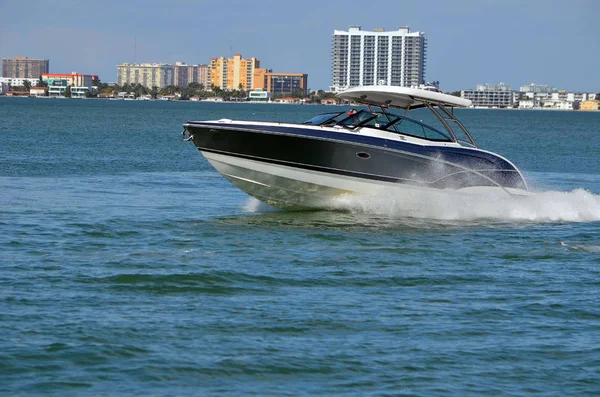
[210,54,265,90]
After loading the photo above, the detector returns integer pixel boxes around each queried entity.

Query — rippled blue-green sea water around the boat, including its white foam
[0,98,600,396]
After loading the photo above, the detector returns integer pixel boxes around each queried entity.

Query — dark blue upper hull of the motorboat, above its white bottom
[185,122,527,189]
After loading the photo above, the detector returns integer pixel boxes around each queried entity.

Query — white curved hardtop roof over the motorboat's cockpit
[337,85,471,109]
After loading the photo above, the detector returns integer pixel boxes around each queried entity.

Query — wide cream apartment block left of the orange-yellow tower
[117,63,175,89]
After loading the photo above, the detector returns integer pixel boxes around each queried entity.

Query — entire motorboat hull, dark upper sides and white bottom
[186,123,526,208]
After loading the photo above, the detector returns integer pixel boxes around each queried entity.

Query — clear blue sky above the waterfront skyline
[0,0,600,92]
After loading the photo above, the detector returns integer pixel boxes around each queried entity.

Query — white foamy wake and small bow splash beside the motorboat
[244,189,600,222]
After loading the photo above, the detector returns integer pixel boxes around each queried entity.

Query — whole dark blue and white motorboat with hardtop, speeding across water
[184,86,527,209]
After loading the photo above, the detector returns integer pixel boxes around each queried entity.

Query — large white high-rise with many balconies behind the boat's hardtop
[330,26,427,92]
